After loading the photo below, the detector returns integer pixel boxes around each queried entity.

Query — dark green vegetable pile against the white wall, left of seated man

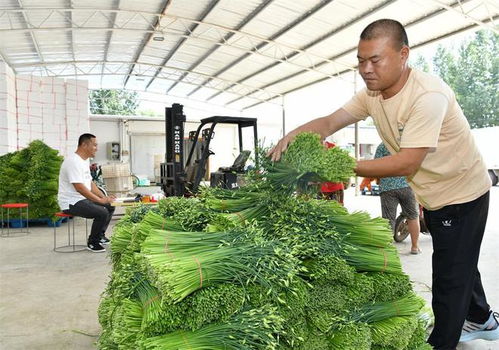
[0,140,62,218]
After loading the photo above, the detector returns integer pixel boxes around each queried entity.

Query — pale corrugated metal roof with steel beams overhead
[0,0,499,109]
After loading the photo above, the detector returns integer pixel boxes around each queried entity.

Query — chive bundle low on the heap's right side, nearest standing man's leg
[350,293,425,323]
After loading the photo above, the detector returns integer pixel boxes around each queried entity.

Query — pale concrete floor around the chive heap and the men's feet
[0,186,499,350]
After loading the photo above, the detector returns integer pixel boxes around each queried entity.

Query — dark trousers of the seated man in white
[64,199,114,243]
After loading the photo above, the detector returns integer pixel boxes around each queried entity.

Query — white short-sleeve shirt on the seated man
[57,153,92,210]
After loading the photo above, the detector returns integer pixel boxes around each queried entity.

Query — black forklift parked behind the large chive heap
[161,103,258,196]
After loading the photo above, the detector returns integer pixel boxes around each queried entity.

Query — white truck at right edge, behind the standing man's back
[471,126,499,186]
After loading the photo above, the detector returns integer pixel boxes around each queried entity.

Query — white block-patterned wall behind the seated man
[0,62,90,155]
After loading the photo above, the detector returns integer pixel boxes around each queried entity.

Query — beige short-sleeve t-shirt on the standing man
[343,69,491,210]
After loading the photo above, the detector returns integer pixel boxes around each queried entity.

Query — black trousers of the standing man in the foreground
[424,192,490,350]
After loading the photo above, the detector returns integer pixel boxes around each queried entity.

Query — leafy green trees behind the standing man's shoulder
[433,31,499,128]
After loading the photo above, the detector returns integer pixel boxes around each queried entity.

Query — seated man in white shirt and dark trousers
[57,134,114,253]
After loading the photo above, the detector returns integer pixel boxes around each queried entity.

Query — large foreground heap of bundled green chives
[98,134,431,350]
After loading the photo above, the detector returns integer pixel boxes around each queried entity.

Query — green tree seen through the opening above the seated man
[89,89,139,115]
